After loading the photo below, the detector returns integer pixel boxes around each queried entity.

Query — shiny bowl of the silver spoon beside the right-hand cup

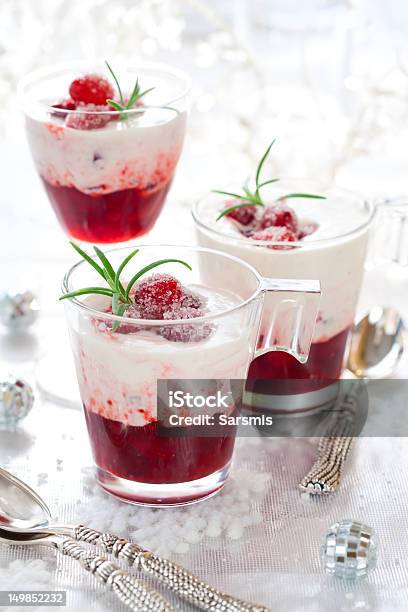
[347,306,406,379]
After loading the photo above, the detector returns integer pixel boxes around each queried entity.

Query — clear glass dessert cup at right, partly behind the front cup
[193,180,375,409]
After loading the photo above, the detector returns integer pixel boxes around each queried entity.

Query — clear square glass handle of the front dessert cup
[255,278,321,363]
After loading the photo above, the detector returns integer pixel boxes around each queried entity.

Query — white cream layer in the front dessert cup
[72,287,254,426]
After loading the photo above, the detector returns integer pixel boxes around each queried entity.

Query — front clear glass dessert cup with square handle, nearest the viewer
[63,245,320,506]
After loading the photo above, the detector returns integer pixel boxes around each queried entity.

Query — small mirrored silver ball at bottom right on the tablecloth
[320,519,378,580]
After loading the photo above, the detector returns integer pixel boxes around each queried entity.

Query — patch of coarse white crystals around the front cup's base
[76,470,270,556]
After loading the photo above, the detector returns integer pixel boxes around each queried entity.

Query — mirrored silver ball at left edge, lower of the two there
[0,376,34,429]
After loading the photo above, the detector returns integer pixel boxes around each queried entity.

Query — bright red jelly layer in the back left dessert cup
[43,179,172,243]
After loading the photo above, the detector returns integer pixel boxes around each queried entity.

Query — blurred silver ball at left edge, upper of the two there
[0,290,39,332]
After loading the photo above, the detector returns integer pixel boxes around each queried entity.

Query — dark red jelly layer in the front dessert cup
[85,408,235,484]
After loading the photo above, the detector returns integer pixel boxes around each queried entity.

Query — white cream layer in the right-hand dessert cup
[196,197,369,342]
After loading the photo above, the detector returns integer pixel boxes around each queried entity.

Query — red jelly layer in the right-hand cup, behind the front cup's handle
[247,328,350,393]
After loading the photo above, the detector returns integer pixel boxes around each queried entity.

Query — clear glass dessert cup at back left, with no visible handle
[19,62,190,244]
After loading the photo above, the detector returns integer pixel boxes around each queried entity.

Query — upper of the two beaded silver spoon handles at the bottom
[72,525,269,612]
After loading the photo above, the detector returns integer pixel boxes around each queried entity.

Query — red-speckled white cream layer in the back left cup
[26,111,187,195]
